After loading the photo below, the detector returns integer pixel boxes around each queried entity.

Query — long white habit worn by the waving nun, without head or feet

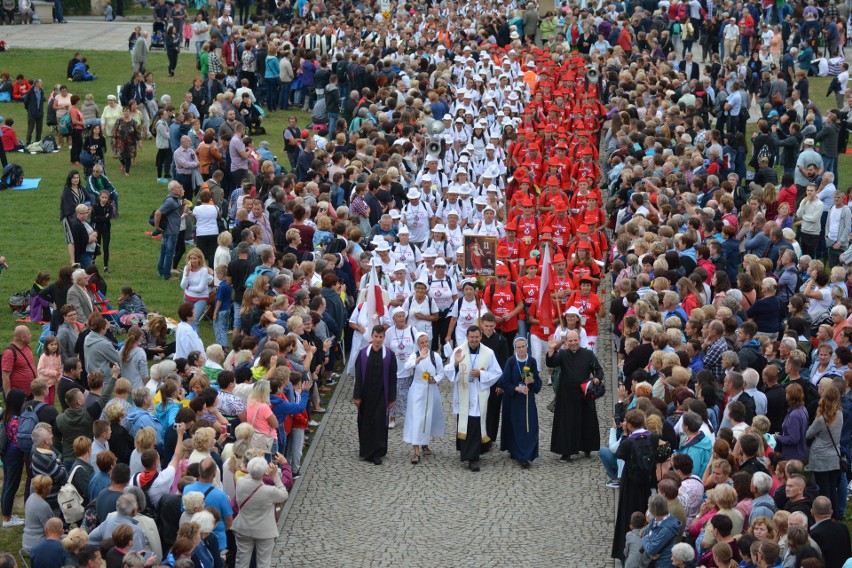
[402,352,446,446]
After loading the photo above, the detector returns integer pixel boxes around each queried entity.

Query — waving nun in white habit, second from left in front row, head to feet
[402,332,444,464]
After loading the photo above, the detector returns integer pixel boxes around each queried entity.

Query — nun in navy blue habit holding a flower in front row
[496,337,541,469]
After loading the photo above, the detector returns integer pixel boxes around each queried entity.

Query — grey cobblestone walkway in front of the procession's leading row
[273,324,615,568]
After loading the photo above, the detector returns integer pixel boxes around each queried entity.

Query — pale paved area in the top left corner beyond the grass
[0,17,146,51]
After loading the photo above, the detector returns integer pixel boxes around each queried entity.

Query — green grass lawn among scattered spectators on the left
[0,50,310,551]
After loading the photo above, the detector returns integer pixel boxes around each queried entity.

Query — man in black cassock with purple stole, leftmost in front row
[353,325,396,465]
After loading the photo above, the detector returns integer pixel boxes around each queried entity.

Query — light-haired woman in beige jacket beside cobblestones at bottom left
[231,458,288,568]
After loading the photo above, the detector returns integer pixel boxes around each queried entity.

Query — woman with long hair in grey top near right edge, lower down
[805,386,843,511]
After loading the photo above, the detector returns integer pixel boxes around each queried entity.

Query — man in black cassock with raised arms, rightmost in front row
[545,331,604,462]
